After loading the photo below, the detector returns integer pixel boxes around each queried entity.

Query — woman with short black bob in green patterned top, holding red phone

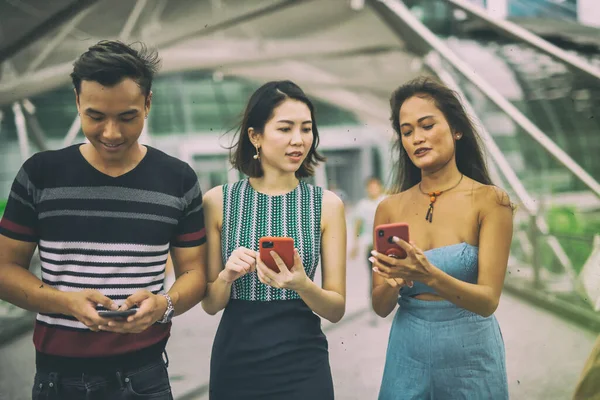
[202,81,346,400]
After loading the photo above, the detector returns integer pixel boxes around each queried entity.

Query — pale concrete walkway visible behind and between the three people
[0,255,595,400]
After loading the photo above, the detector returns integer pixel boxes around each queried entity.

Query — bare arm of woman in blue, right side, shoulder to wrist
[425,187,513,317]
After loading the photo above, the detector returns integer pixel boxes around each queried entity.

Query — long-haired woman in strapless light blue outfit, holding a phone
[370,78,513,400]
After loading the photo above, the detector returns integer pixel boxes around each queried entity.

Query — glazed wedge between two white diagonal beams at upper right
[410,0,600,179]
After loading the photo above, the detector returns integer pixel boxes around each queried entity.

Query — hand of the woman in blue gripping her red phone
[370,236,433,283]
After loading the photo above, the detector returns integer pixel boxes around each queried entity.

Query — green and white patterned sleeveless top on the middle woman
[221,179,323,301]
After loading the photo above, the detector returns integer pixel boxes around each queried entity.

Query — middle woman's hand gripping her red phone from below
[256,249,310,291]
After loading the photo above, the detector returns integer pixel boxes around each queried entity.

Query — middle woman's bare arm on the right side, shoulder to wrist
[298,190,347,323]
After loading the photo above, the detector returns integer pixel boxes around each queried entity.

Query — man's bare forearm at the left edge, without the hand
[0,264,68,314]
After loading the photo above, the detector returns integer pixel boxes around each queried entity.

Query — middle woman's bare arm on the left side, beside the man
[202,186,232,315]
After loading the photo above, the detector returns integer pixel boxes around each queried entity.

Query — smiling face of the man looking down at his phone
[76,78,152,163]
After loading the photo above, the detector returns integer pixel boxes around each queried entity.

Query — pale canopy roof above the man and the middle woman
[0,0,432,128]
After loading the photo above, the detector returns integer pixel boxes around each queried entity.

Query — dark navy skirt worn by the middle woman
[210,299,334,400]
